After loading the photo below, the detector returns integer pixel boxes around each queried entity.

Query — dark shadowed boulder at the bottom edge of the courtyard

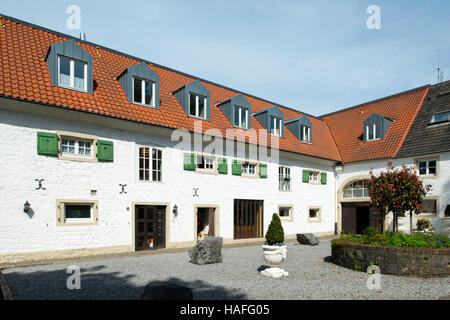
[141,281,194,300]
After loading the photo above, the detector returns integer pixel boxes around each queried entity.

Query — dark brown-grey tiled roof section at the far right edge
[397,81,450,158]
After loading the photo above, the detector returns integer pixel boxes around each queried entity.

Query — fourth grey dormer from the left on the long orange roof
[218,94,252,129]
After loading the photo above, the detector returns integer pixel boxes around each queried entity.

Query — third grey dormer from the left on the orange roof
[173,80,211,121]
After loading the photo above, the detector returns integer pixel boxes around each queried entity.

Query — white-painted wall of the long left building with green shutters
[0,106,335,254]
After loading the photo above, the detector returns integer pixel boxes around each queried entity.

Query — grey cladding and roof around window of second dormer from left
[117,62,160,109]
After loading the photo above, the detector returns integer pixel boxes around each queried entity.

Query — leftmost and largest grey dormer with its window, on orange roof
[46,40,94,93]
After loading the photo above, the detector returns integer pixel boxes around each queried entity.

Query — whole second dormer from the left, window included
[117,62,160,109]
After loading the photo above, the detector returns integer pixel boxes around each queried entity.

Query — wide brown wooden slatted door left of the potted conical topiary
[234,199,264,239]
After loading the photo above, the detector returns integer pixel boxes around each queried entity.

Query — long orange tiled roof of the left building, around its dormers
[0,16,341,161]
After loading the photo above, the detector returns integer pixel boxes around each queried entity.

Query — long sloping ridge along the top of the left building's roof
[0,12,323,121]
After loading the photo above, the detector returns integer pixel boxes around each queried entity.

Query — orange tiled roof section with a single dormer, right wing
[323,86,429,163]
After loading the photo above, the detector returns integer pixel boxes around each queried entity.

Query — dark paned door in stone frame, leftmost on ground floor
[135,206,166,251]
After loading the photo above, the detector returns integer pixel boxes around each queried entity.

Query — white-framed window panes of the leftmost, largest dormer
[58,56,87,91]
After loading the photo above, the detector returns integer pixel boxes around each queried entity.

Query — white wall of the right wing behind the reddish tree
[337,152,450,233]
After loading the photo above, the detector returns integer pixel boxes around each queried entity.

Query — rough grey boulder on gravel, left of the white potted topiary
[189,237,223,265]
